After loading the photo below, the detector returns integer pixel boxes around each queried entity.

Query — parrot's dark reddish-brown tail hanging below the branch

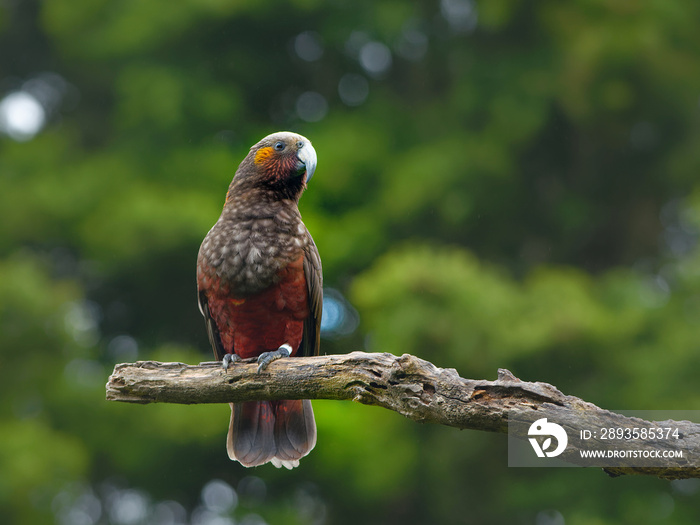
[226,399,316,469]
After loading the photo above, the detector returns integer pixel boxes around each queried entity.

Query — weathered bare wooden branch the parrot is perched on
[107,352,700,479]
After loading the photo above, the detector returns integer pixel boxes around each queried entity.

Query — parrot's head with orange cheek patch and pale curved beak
[229,131,316,202]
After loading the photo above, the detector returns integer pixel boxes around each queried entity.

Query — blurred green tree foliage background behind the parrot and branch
[0,0,700,525]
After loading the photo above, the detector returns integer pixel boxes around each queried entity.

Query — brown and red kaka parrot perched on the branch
[197,132,323,469]
